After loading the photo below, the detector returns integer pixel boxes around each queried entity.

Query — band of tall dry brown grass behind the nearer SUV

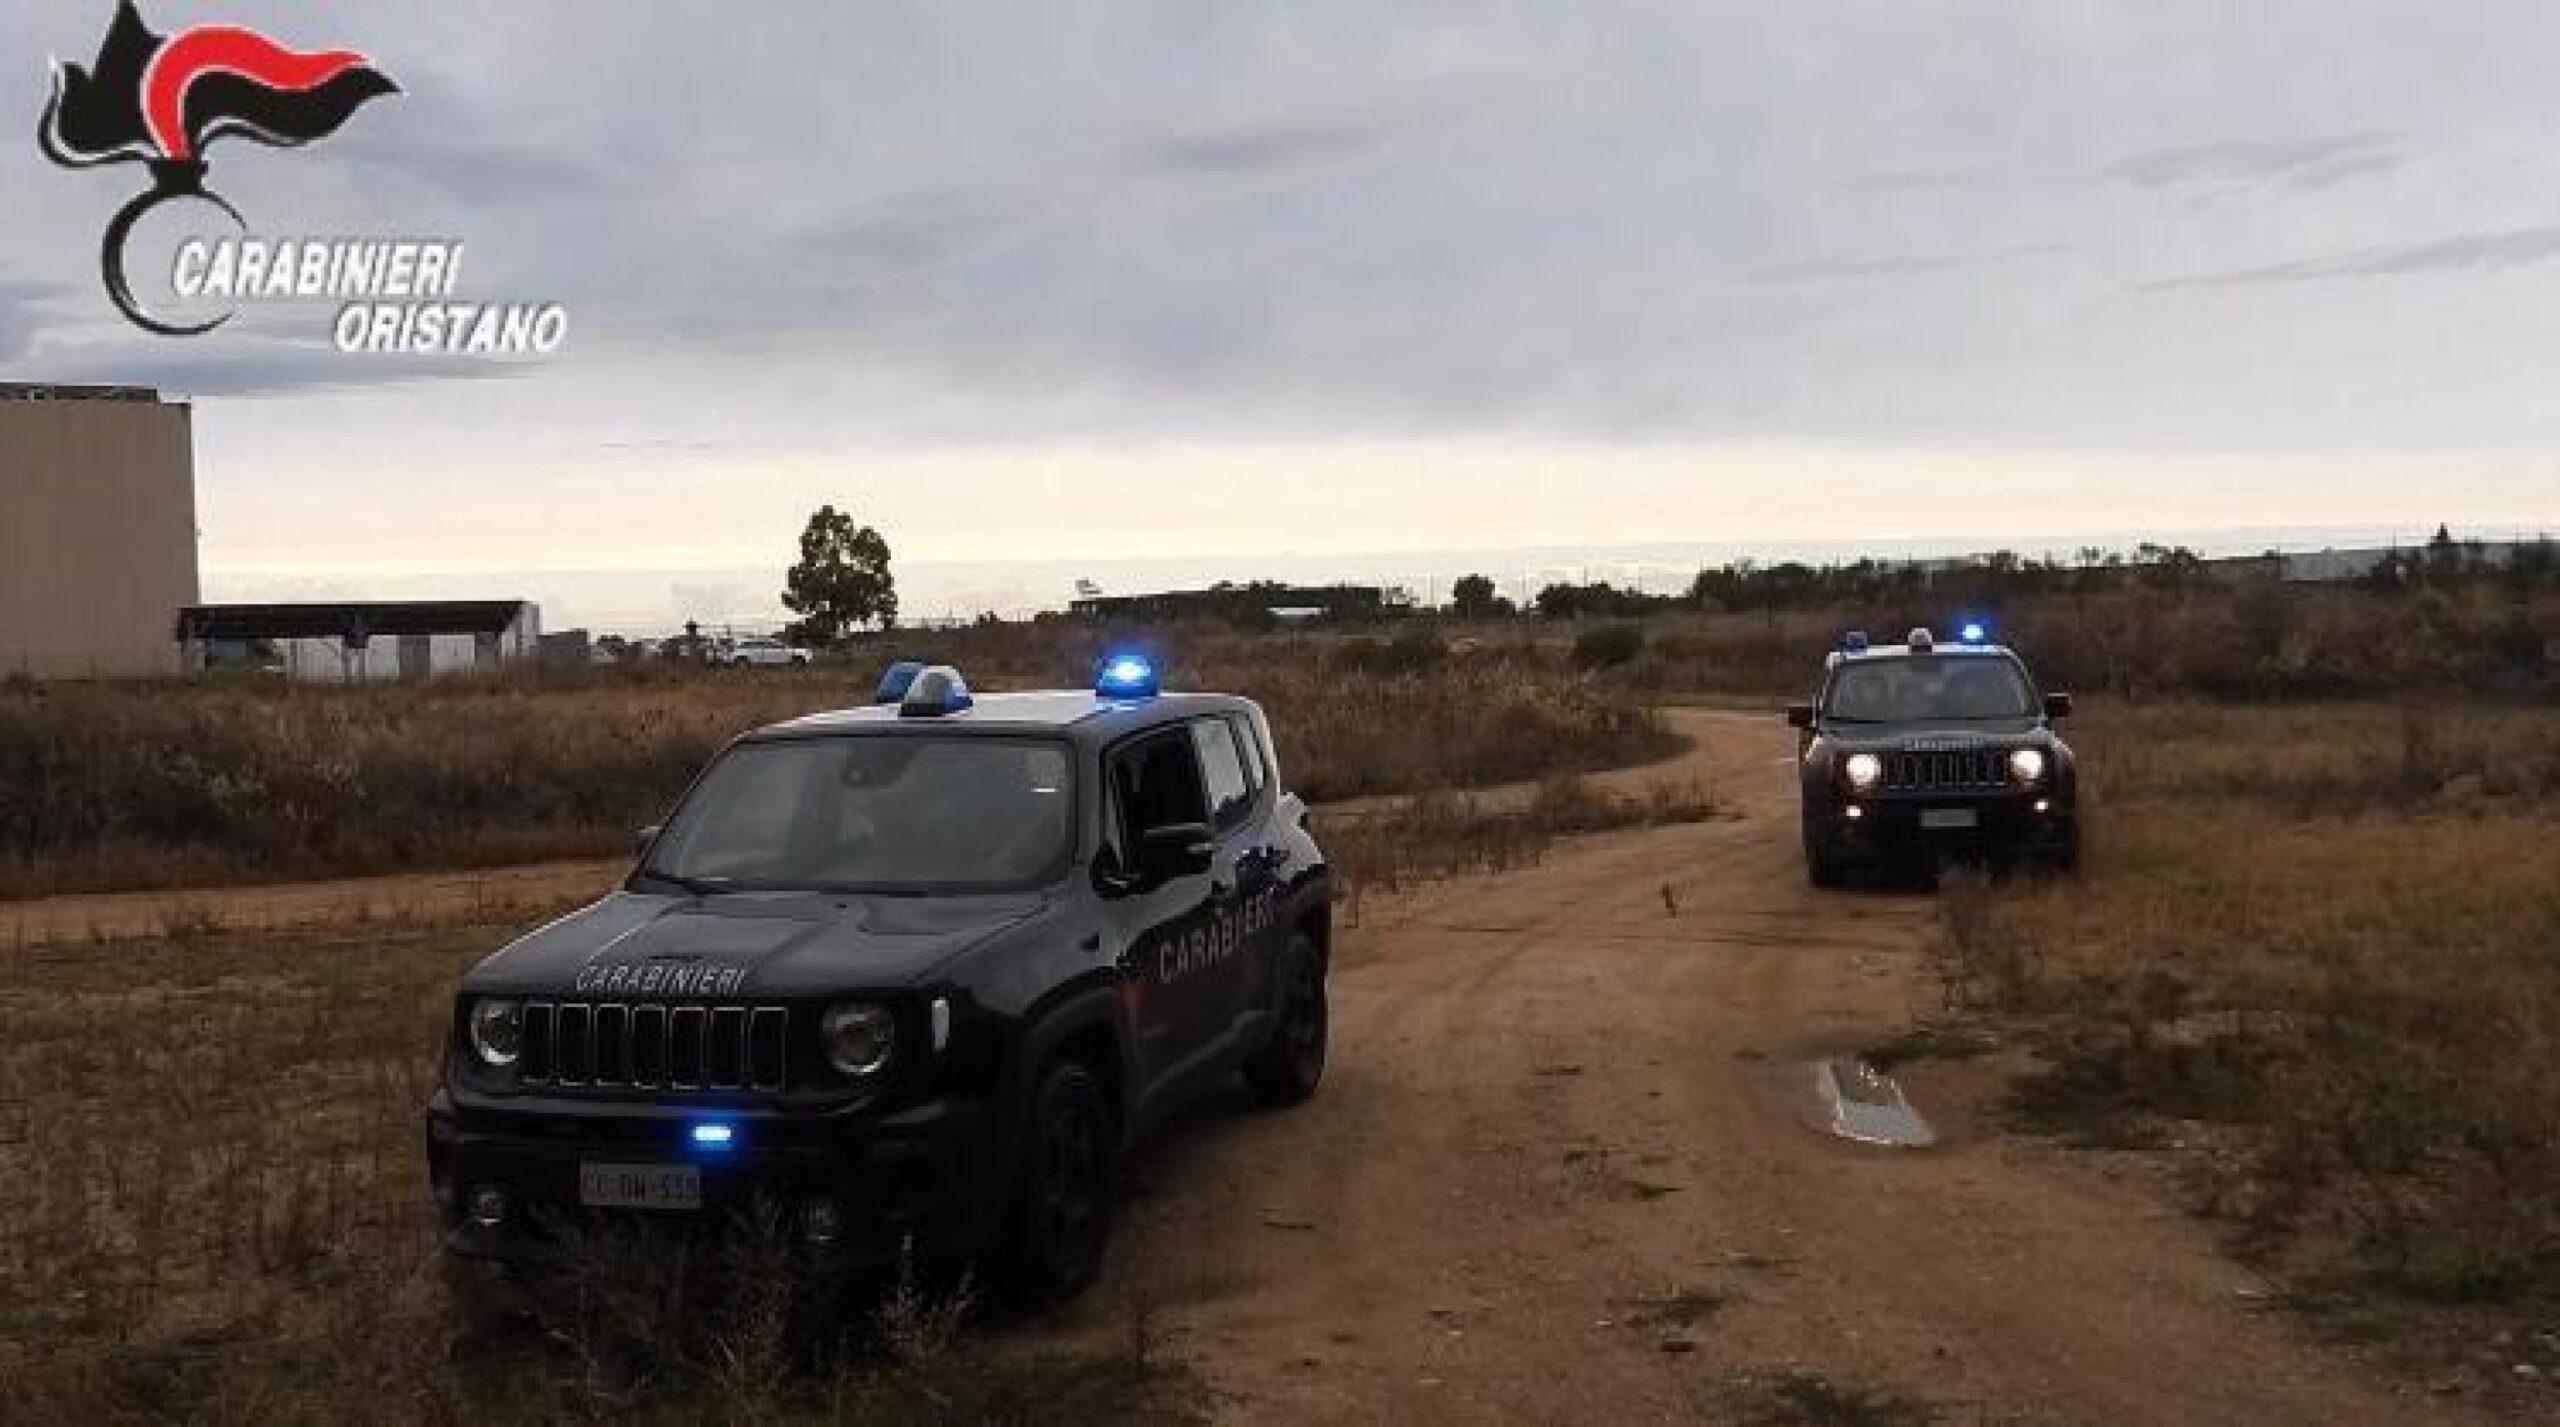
[0,630,1672,897]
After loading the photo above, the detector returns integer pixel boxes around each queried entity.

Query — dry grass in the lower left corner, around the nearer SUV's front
[0,925,1193,1422]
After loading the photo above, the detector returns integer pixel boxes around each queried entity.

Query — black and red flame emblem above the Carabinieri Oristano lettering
[36,0,399,336]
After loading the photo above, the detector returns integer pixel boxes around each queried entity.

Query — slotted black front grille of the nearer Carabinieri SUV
[517,1002,791,1089]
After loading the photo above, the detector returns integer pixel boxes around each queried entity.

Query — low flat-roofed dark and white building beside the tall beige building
[180,599,543,684]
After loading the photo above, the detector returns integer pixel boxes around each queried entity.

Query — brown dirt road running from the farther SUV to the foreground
[1032,712,2450,1424]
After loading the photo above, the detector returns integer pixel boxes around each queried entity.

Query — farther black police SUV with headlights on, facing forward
[1787,623,2079,886]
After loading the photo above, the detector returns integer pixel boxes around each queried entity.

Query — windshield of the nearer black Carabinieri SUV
[640,733,1070,892]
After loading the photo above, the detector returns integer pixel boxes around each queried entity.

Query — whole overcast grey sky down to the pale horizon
[0,0,2560,622]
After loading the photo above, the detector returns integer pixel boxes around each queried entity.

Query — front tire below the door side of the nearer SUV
[996,1061,1119,1309]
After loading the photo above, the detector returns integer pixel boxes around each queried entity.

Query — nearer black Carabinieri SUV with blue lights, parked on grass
[428,656,1331,1301]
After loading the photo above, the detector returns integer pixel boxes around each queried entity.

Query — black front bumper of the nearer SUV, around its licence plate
[428,1091,1011,1266]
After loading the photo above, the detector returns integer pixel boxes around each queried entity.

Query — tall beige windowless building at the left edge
[0,382,200,679]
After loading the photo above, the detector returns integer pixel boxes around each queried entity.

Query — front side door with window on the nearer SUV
[1106,725,1224,1091]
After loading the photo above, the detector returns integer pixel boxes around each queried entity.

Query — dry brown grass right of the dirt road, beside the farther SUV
[1943,705,2560,1314]
